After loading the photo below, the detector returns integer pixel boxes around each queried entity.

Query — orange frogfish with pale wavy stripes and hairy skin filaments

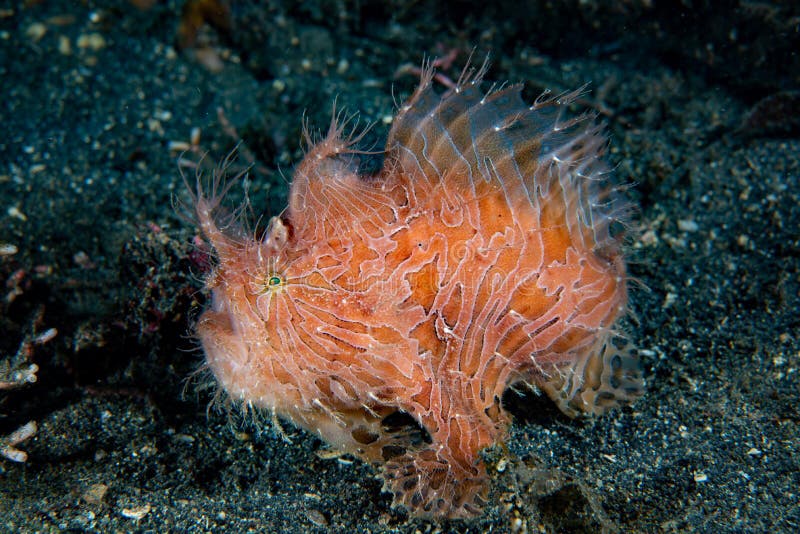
[193,61,643,519]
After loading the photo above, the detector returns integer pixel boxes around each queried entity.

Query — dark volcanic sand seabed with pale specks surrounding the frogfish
[0,0,800,532]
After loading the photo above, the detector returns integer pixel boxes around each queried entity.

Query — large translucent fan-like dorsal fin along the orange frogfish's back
[386,62,623,255]
